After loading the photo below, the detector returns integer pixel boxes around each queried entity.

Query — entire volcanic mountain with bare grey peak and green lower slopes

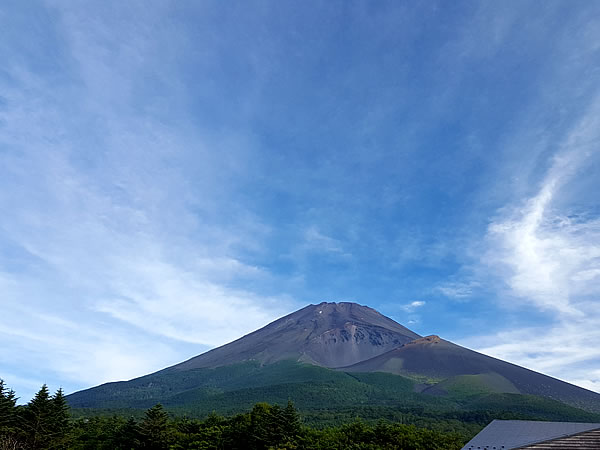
[67,302,600,420]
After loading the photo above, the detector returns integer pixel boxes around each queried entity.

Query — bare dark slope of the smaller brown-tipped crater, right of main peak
[342,336,600,411]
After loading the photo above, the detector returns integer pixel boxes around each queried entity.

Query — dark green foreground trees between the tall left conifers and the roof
[70,403,466,450]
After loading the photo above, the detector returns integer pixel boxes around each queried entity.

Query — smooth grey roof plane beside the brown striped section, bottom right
[463,420,600,450]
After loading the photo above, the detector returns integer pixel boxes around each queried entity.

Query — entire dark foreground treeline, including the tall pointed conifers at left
[0,380,464,450]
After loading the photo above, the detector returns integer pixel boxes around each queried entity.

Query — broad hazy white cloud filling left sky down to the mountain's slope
[0,2,296,395]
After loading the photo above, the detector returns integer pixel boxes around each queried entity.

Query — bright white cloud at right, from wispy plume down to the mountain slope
[462,99,600,390]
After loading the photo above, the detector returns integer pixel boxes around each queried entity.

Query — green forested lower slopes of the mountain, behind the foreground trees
[67,361,600,437]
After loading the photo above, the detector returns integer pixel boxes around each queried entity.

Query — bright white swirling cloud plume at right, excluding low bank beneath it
[484,96,600,315]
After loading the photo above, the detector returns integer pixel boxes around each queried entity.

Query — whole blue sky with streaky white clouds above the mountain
[0,0,600,401]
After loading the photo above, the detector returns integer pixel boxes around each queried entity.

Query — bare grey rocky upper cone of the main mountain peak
[172,302,421,370]
